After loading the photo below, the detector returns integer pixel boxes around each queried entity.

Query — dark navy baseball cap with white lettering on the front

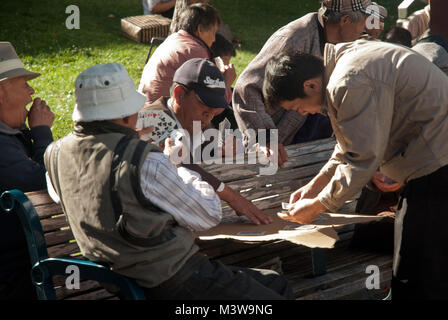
[173,58,231,109]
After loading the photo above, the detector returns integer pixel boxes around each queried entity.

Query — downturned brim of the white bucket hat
[72,91,146,122]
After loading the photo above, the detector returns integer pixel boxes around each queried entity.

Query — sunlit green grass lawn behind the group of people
[0,0,423,138]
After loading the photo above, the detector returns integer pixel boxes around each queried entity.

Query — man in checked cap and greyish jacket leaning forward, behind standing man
[232,0,371,166]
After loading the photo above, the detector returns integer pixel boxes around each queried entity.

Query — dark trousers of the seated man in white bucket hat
[144,254,294,300]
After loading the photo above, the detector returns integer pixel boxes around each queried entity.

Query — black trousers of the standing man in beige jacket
[392,166,448,300]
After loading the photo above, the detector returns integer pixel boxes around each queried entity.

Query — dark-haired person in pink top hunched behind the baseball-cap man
[138,3,236,103]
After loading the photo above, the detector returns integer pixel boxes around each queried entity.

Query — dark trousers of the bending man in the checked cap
[291,113,333,144]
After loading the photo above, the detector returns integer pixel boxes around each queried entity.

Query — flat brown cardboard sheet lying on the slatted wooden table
[196,210,384,248]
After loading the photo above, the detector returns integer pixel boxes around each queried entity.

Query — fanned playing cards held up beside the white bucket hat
[136,110,176,144]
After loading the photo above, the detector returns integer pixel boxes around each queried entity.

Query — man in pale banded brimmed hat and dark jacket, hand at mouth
[0,42,54,299]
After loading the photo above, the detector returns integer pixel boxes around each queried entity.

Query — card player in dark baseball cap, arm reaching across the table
[142,58,272,228]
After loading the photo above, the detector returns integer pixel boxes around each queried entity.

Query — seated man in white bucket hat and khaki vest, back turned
[45,63,292,299]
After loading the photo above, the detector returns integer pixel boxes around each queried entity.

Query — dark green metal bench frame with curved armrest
[0,189,146,300]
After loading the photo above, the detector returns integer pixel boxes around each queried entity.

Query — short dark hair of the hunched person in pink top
[179,3,221,34]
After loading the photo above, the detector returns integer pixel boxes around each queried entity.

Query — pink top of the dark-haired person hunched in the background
[138,30,232,103]
